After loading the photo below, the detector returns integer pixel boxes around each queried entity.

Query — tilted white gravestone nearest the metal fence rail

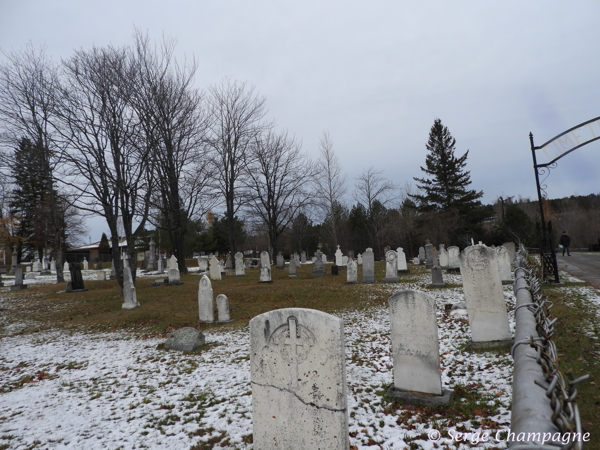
[459,245,511,343]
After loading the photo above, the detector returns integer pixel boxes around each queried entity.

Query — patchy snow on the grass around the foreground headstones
[0,268,536,450]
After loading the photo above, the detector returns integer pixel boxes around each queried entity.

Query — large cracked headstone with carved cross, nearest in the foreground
[250,308,349,450]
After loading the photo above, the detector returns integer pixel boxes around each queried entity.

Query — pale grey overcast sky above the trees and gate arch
[0,0,600,240]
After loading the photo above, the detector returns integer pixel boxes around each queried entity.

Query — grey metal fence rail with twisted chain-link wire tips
[509,247,589,450]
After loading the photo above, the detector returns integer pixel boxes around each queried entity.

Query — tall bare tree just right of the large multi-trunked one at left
[134,33,218,273]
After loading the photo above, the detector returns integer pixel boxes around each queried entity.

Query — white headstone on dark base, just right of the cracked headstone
[388,290,450,403]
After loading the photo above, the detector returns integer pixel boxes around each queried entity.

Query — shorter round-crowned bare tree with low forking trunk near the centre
[246,130,315,255]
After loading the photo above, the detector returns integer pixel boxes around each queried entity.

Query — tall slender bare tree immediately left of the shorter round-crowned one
[208,79,270,253]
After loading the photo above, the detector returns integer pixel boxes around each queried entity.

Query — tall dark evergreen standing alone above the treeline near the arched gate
[409,119,486,244]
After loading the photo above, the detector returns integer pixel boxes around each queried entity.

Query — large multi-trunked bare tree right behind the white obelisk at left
[56,47,154,287]
